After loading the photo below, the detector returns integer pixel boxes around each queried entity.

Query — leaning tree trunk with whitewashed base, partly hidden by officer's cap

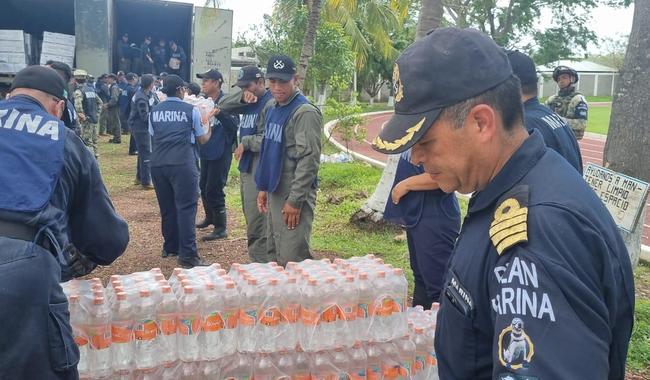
[351,0,446,223]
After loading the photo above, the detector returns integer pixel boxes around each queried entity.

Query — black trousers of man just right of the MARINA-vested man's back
[199,152,232,213]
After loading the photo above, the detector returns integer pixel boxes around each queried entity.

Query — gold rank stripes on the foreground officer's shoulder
[489,198,528,255]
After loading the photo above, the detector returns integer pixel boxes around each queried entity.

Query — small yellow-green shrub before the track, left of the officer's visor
[325,98,366,153]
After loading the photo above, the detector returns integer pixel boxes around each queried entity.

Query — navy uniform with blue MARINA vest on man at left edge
[0,95,129,379]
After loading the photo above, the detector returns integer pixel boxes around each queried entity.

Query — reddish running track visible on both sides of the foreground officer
[334,112,650,245]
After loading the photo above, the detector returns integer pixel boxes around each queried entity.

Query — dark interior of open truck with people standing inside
[113,0,193,79]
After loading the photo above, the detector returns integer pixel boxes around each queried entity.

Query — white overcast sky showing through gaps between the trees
[185,0,634,52]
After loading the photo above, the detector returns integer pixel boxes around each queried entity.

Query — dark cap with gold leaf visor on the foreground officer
[373,28,512,154]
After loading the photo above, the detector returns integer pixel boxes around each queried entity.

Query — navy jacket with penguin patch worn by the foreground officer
[435,131,634,380]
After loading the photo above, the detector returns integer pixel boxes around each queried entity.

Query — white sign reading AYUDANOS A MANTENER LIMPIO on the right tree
[583,163,649,232]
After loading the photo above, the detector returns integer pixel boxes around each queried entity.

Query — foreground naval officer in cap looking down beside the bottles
[374,28,634,380]
